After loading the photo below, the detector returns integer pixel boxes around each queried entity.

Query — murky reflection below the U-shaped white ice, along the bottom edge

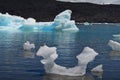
[44,74,95,80]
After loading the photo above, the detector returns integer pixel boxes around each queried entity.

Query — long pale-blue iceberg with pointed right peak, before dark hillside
[0,10,79,31]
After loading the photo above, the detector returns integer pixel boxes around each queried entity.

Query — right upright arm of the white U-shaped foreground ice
[76,47,98,74]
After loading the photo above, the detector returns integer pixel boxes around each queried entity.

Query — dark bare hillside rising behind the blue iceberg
[0,0,120,23]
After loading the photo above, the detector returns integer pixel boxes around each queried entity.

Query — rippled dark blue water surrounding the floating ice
[0,24,120,80]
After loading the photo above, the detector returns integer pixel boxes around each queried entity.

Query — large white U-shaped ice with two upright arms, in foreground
[36,45,98,76]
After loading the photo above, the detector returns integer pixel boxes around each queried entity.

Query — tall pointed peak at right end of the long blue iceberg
[54,10,79,31]
